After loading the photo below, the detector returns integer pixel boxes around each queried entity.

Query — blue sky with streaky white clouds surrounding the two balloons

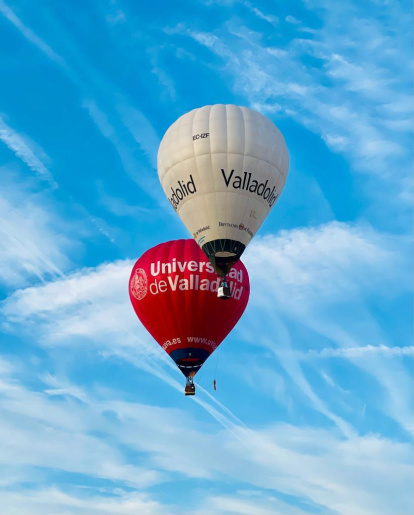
[0,0,414,515]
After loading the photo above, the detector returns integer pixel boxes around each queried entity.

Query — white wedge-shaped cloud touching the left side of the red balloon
[1,260,182,391]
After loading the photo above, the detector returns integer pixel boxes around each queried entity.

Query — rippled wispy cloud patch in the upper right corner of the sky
[171,0,412,214]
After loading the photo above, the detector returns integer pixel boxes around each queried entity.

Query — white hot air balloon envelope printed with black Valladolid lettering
[158,104,289,284]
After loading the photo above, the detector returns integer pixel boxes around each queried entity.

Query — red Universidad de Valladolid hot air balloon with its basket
[129,240,250,395]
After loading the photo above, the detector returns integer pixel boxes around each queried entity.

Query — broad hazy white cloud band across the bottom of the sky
[0,354,412,515]
